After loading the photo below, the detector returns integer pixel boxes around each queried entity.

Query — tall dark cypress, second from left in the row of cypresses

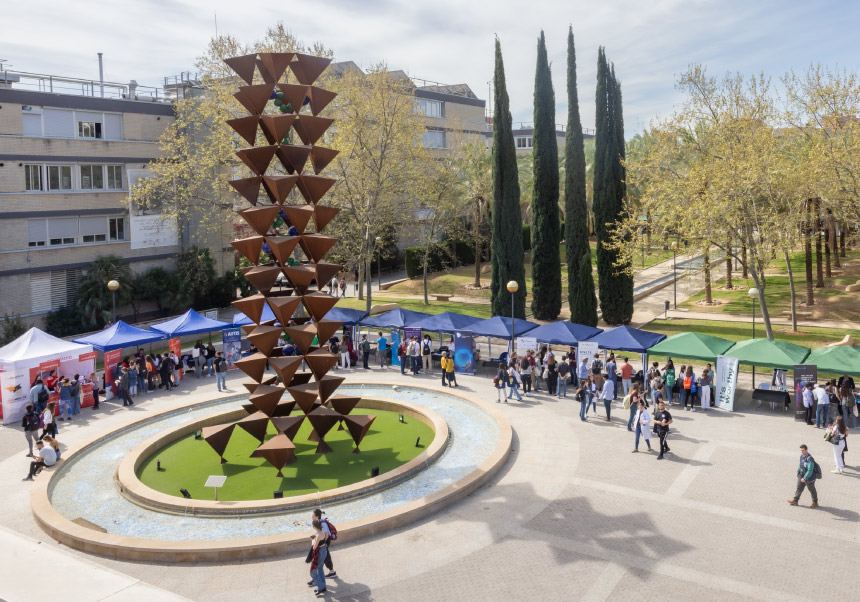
[531,31,561,320]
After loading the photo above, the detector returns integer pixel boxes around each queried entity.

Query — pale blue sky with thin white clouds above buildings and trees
[0,0,860,138]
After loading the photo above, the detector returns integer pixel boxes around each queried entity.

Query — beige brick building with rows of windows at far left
[0,71,187,325]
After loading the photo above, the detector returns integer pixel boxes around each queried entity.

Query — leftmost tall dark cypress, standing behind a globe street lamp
[490,38,526,319]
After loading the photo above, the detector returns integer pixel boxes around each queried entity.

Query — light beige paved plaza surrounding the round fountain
[0,369,860,602]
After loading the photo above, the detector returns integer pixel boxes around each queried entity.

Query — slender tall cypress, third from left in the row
[564,27,597,325]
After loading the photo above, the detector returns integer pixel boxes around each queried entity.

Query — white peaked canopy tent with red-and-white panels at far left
[0,328,95,424]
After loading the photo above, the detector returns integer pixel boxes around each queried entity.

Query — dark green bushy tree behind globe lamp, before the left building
[77,255,134,330]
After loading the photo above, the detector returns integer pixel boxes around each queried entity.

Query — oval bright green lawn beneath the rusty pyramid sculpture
[138,408,433,501]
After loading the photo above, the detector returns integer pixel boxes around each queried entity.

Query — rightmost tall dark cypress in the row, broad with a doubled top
[594,48,633,324]
